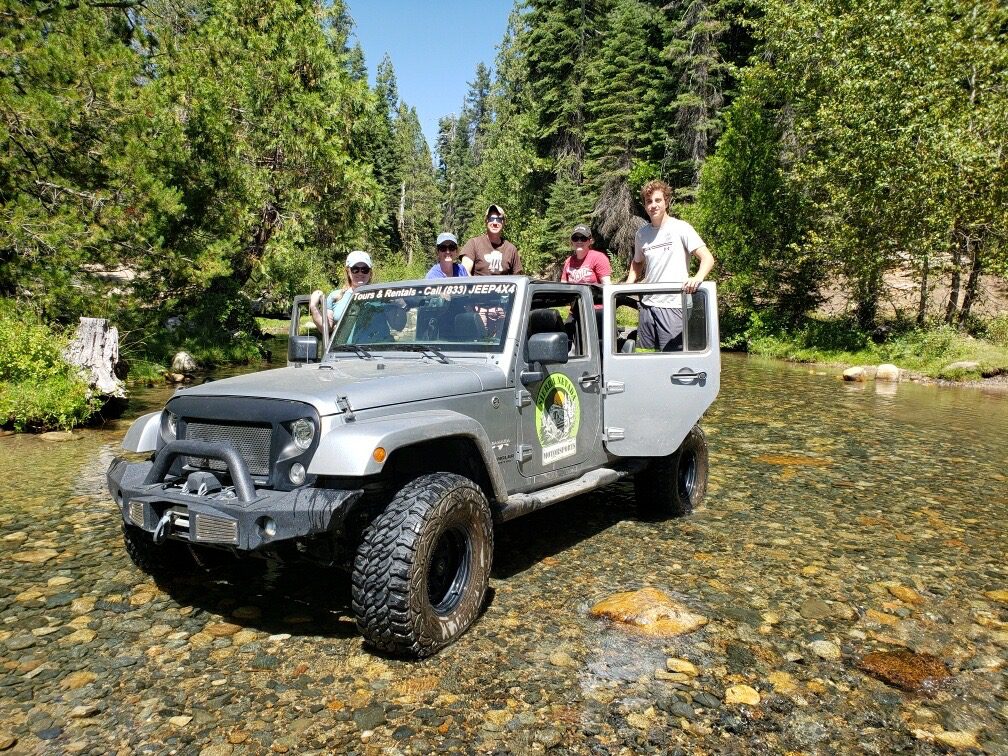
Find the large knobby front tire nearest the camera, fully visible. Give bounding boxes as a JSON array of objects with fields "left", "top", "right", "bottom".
[{"left": 352, "top": 473, "right": 494, "bottom": 658}]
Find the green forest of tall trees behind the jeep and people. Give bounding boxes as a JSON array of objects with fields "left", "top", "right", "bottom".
[{"left": 0, "top": 0, "right": 1008, "bottom": 426}]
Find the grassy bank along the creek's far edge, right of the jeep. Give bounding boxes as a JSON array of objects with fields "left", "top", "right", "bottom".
[{"left": 742, "top": 317, "right": 1008, "bottom": 381}]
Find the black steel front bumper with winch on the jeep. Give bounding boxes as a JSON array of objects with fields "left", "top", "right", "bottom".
[{"left": 106, "top": 449, "right": 364, "bottom": 551}]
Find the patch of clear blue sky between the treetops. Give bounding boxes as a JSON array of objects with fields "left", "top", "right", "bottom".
[{"left": 347, "top": 0, "right": 514, "bottom": 155}]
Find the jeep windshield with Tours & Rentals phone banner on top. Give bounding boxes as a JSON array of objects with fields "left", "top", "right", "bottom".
[{"left": 330, "top": 278, "right": 518, "bottom": 352}]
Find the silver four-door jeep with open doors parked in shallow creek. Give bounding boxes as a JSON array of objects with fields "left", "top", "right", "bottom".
[{"left": 108, "top": 276, "right": 721, "bottom": 656}]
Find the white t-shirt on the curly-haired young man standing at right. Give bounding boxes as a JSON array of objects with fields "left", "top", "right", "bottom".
[{"left": 633, "top": 216, "right": 705, "bottom": 307}]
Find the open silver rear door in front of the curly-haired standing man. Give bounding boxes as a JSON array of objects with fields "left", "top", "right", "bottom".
[{"left": 602, "top": 283, "right": 721, "bottom": 457}]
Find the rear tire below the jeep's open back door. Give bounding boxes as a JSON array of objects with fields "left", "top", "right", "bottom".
[{"left": 634, "top": 425, "right": 709, "bottom": 518}]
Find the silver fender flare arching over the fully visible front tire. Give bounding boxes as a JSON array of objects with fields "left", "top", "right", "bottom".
[{"left": 307, "top": 409, "right": 507, "bottom": 501}]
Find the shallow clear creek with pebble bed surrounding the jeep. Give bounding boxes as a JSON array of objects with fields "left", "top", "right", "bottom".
[{"left": 0, "top": 357, "right": 1008, "bottom": 755}]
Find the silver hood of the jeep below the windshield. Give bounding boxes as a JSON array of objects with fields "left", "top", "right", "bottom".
[{"left": 173, "top": 357, "right": 506, "bottom": 415}]
